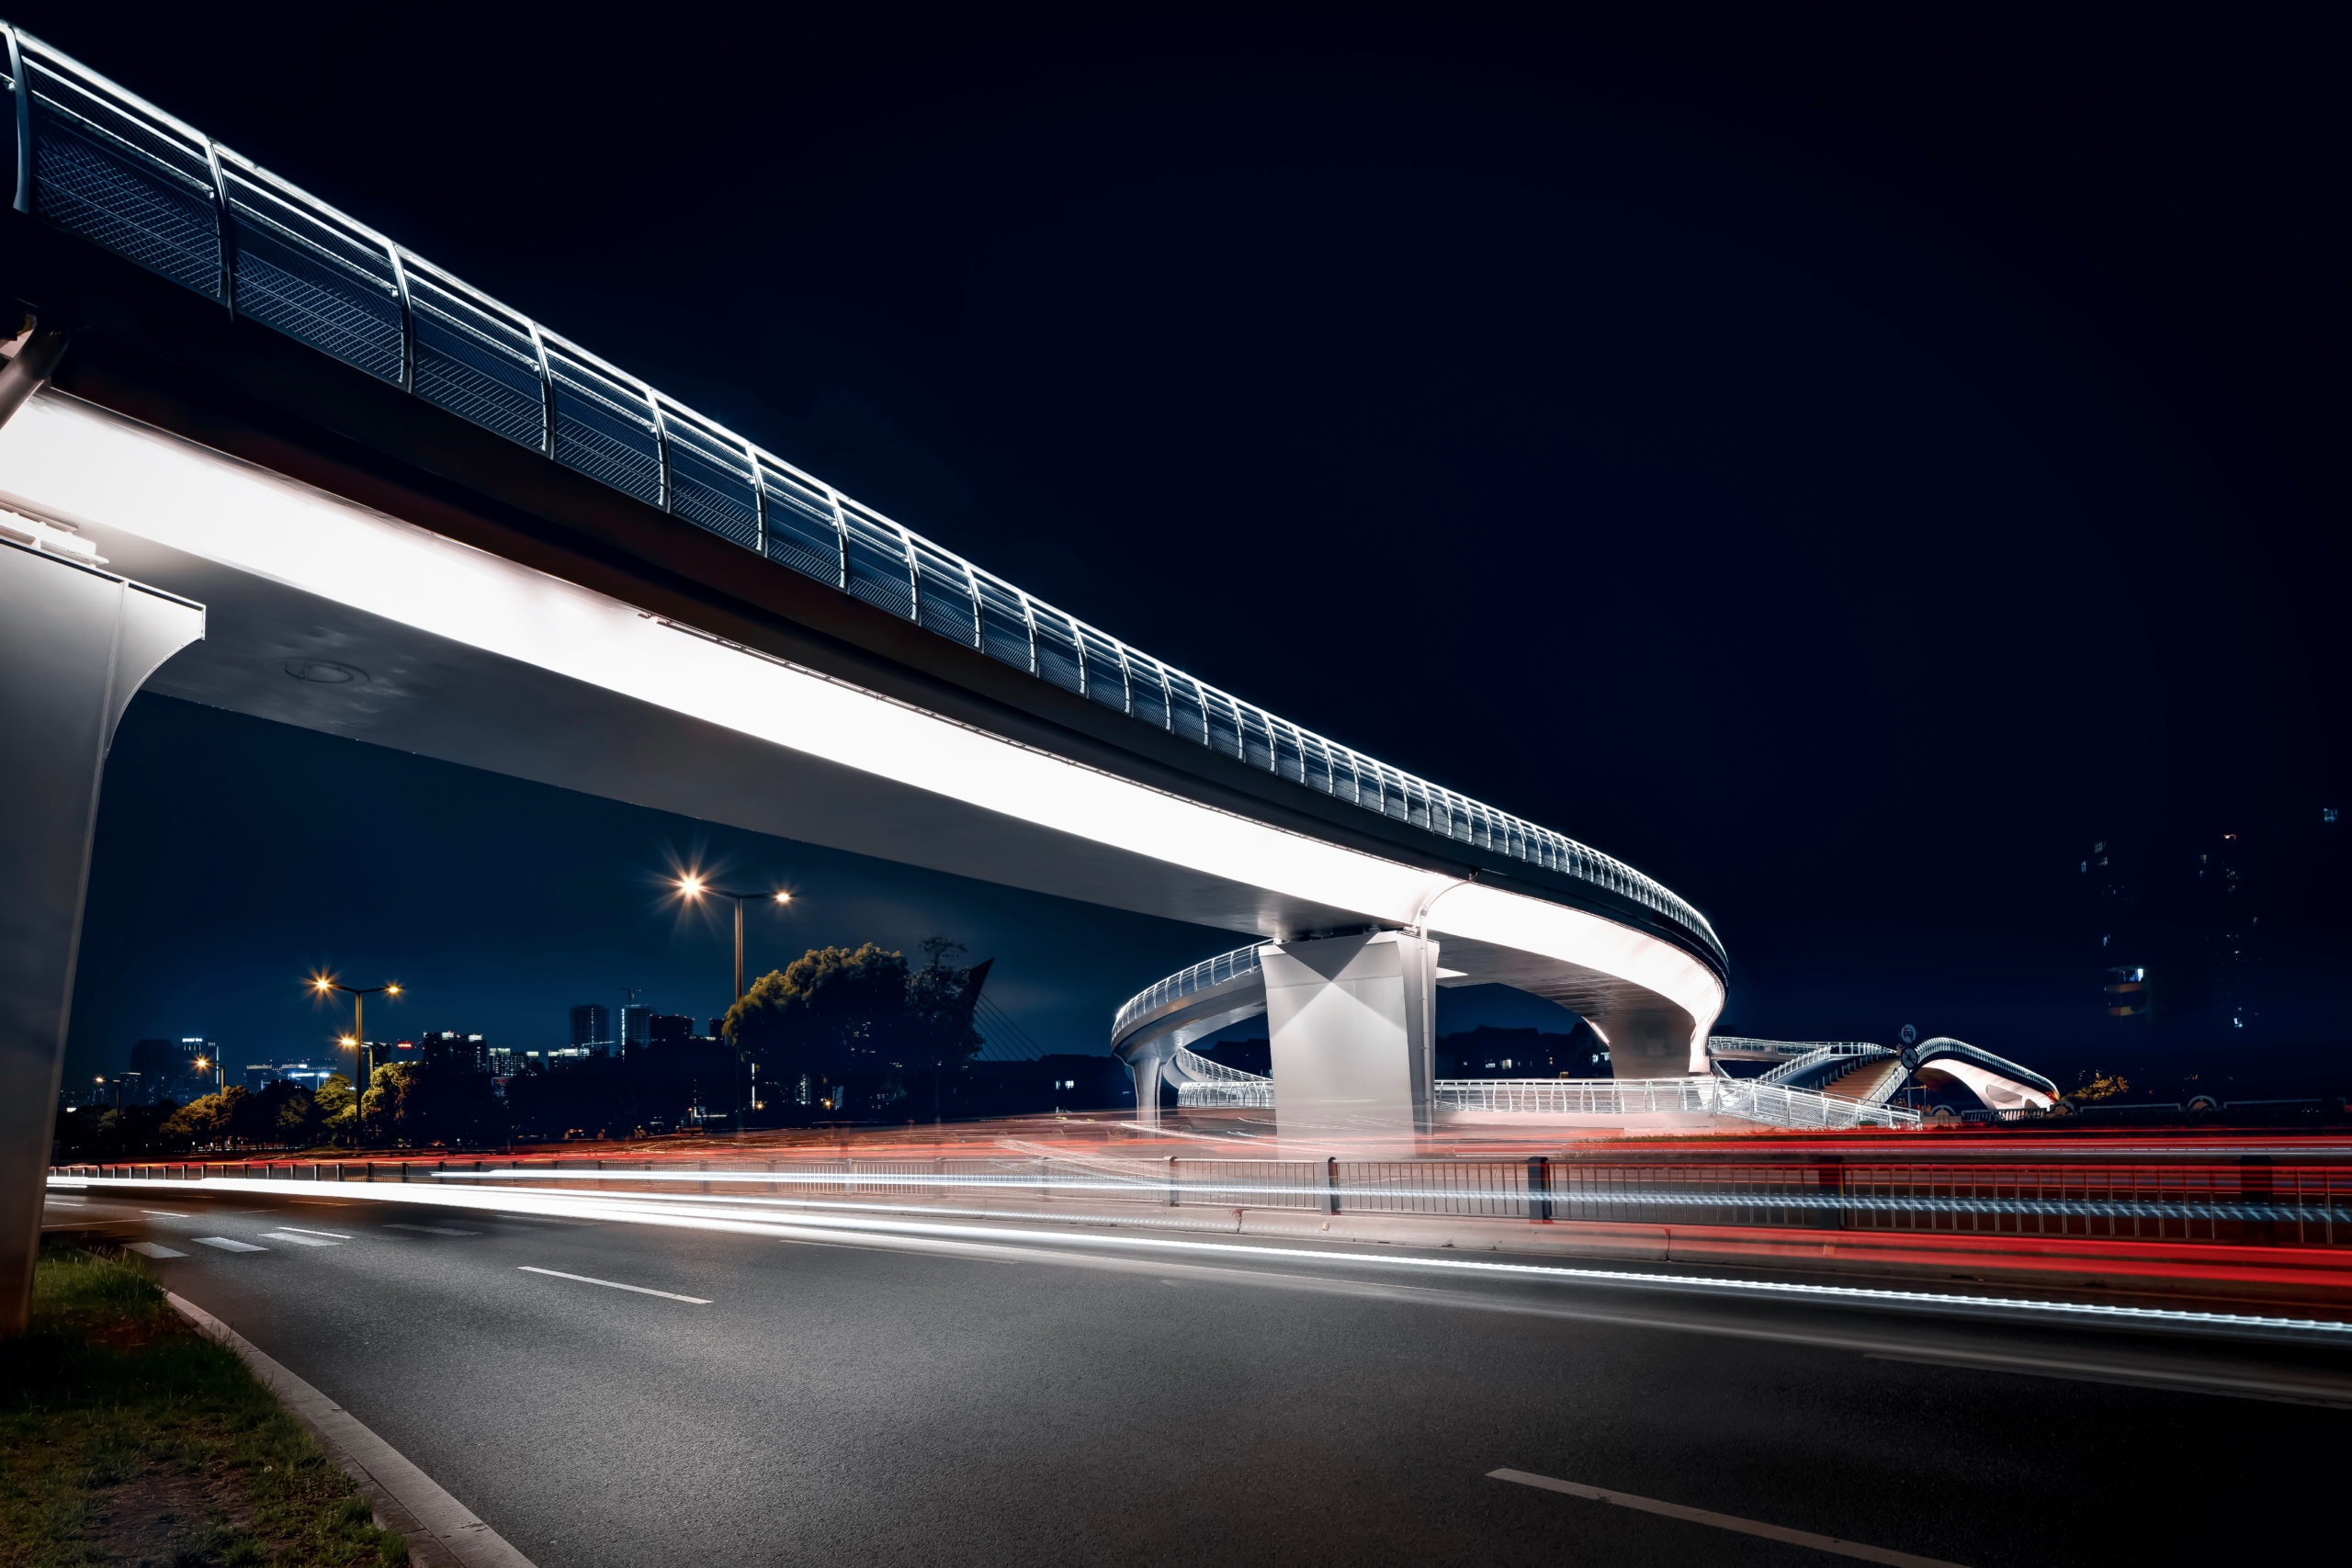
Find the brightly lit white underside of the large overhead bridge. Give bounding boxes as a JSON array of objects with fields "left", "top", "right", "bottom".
[{"left": 0, "top": 390, "right": 1722, "bottom": 1034}]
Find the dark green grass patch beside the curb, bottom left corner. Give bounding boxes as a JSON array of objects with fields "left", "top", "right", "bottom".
[{"left": 0, "top": 1248, "right": 409, "bottom": 1568}]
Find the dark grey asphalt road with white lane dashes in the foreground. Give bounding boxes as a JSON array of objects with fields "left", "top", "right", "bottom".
[{"left": 51, "top": 1192, "right": 2352, "bottom": 1568}]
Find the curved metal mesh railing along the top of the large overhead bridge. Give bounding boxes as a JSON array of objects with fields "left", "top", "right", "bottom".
[{"left": 0, "top": 24, "right": 1724, "bottom": 966}]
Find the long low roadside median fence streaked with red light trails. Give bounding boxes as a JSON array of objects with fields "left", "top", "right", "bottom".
[{"left": 51, "top": 1152, "right": 2352, "bottom": 1248}]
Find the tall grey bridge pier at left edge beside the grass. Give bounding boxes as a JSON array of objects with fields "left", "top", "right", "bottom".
[{"left": 0, "top": 543, "right": 205, "bottom": 1333}]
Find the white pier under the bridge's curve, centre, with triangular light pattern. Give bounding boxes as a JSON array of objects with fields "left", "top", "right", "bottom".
[{"left": 1259, "top": 931, "right": 1437, "bottom": 1155}]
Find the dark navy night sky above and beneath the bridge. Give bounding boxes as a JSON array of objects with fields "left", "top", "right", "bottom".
[{"left": 41, "top": 5, "right": 2352, "bottom": 1100}]
